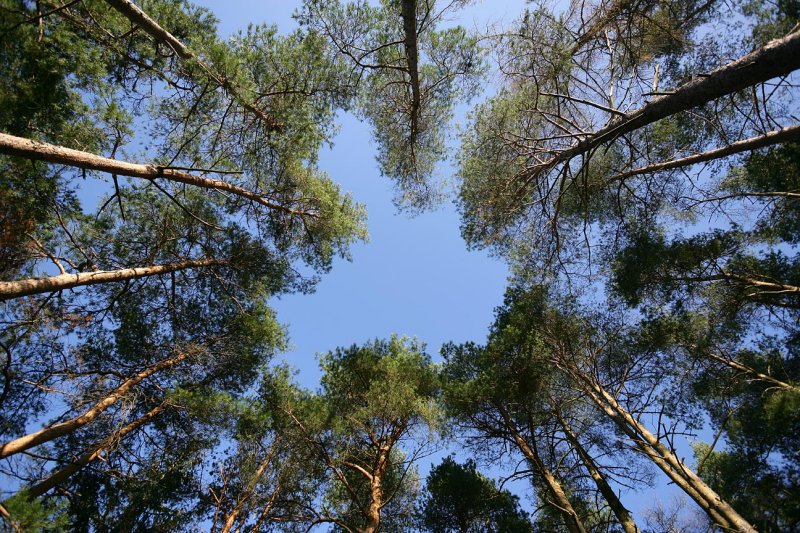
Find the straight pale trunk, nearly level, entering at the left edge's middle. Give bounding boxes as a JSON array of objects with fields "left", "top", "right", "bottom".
[{"left": 0, "top": 259, "right": 226, "bottom": 301}]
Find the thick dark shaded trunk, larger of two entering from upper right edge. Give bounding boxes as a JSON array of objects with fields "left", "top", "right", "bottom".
[{"left": 521, "top": 31, "right": 800, "bottom": 187}]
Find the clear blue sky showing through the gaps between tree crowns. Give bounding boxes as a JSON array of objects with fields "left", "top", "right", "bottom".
[{"left": 194, "top": 0, "right": 691, "bottom": 525}]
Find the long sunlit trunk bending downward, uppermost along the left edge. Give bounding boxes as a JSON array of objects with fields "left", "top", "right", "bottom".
[{"left": 0, "top": 133, "right": 314, "bottom": 216}]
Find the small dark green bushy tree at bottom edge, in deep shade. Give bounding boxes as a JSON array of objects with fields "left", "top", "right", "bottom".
[{"left": 417, "top": 456, "right": 533, "bottom": 533}]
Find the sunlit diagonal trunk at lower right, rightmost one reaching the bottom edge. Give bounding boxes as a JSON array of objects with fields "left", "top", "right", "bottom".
[{"left": 562, "top": 365, "right": 756, "bottom": 533}]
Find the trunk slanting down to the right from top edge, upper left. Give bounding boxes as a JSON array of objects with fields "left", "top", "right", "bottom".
[{"left": 106, "top": 0, "right": 284, "bottom": 131}]
